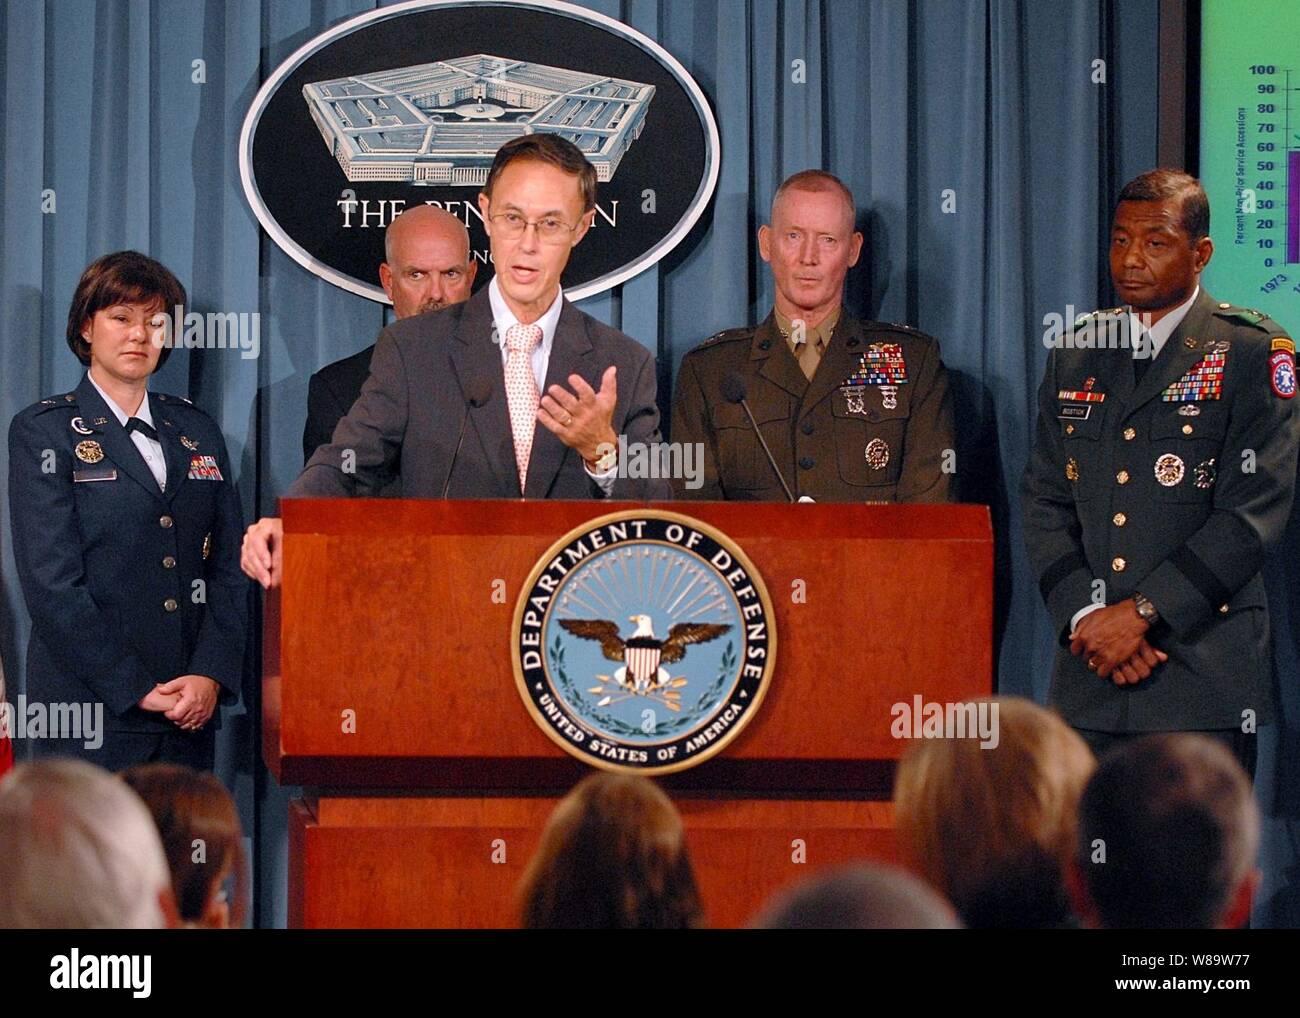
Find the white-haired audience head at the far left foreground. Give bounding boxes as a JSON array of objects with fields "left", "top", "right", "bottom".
[{"left": 0, "top": 759, "right": 177, "bottom": 930}]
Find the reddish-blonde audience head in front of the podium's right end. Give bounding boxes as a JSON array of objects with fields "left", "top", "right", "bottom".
[{"left": 894, "top": 697, "right": 1095, "bottom": 928}]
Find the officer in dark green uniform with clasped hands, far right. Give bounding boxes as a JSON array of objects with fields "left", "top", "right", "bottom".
[{"left": 1022, "top": 170, "right": 1300, "bottom": 775}]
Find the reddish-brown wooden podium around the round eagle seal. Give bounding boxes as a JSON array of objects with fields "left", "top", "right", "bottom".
[{"left": 263, "top": 499, "right": 993, "bottom": 927}]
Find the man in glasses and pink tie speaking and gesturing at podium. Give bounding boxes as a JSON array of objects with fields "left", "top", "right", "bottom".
[{"left": 242, "top": 134, "right": 670, "bottom": 586}]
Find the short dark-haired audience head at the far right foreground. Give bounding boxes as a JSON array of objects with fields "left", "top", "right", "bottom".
[{"left": 1070, "top": 733, "right": 1260, "bottom": 930}]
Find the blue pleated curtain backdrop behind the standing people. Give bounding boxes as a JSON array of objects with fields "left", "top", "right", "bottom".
[{"left": 0, "top": 0, "right": 1300, "bottom": 926}]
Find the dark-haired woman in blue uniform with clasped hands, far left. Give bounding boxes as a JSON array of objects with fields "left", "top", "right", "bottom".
[{"left": 9, "top": 251, "right": 247, "bottom": 771}]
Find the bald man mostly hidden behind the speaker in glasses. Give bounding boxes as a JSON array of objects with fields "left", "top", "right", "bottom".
[{"left": 303, "top": 205, "right": 478, "bottom": 495}]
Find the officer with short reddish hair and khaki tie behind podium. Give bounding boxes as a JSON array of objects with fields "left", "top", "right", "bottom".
[{"left": 672, "top": 170, "right": 956, "bottom": 502}]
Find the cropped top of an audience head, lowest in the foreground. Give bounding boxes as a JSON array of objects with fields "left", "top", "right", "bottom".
[{"left": 753, "top": 865, "right": 962, "bottom": 930}]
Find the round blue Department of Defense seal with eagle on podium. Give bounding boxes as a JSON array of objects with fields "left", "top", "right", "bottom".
[{"left": 511, "top": 510, "right": 776, "bottom": 775}]
